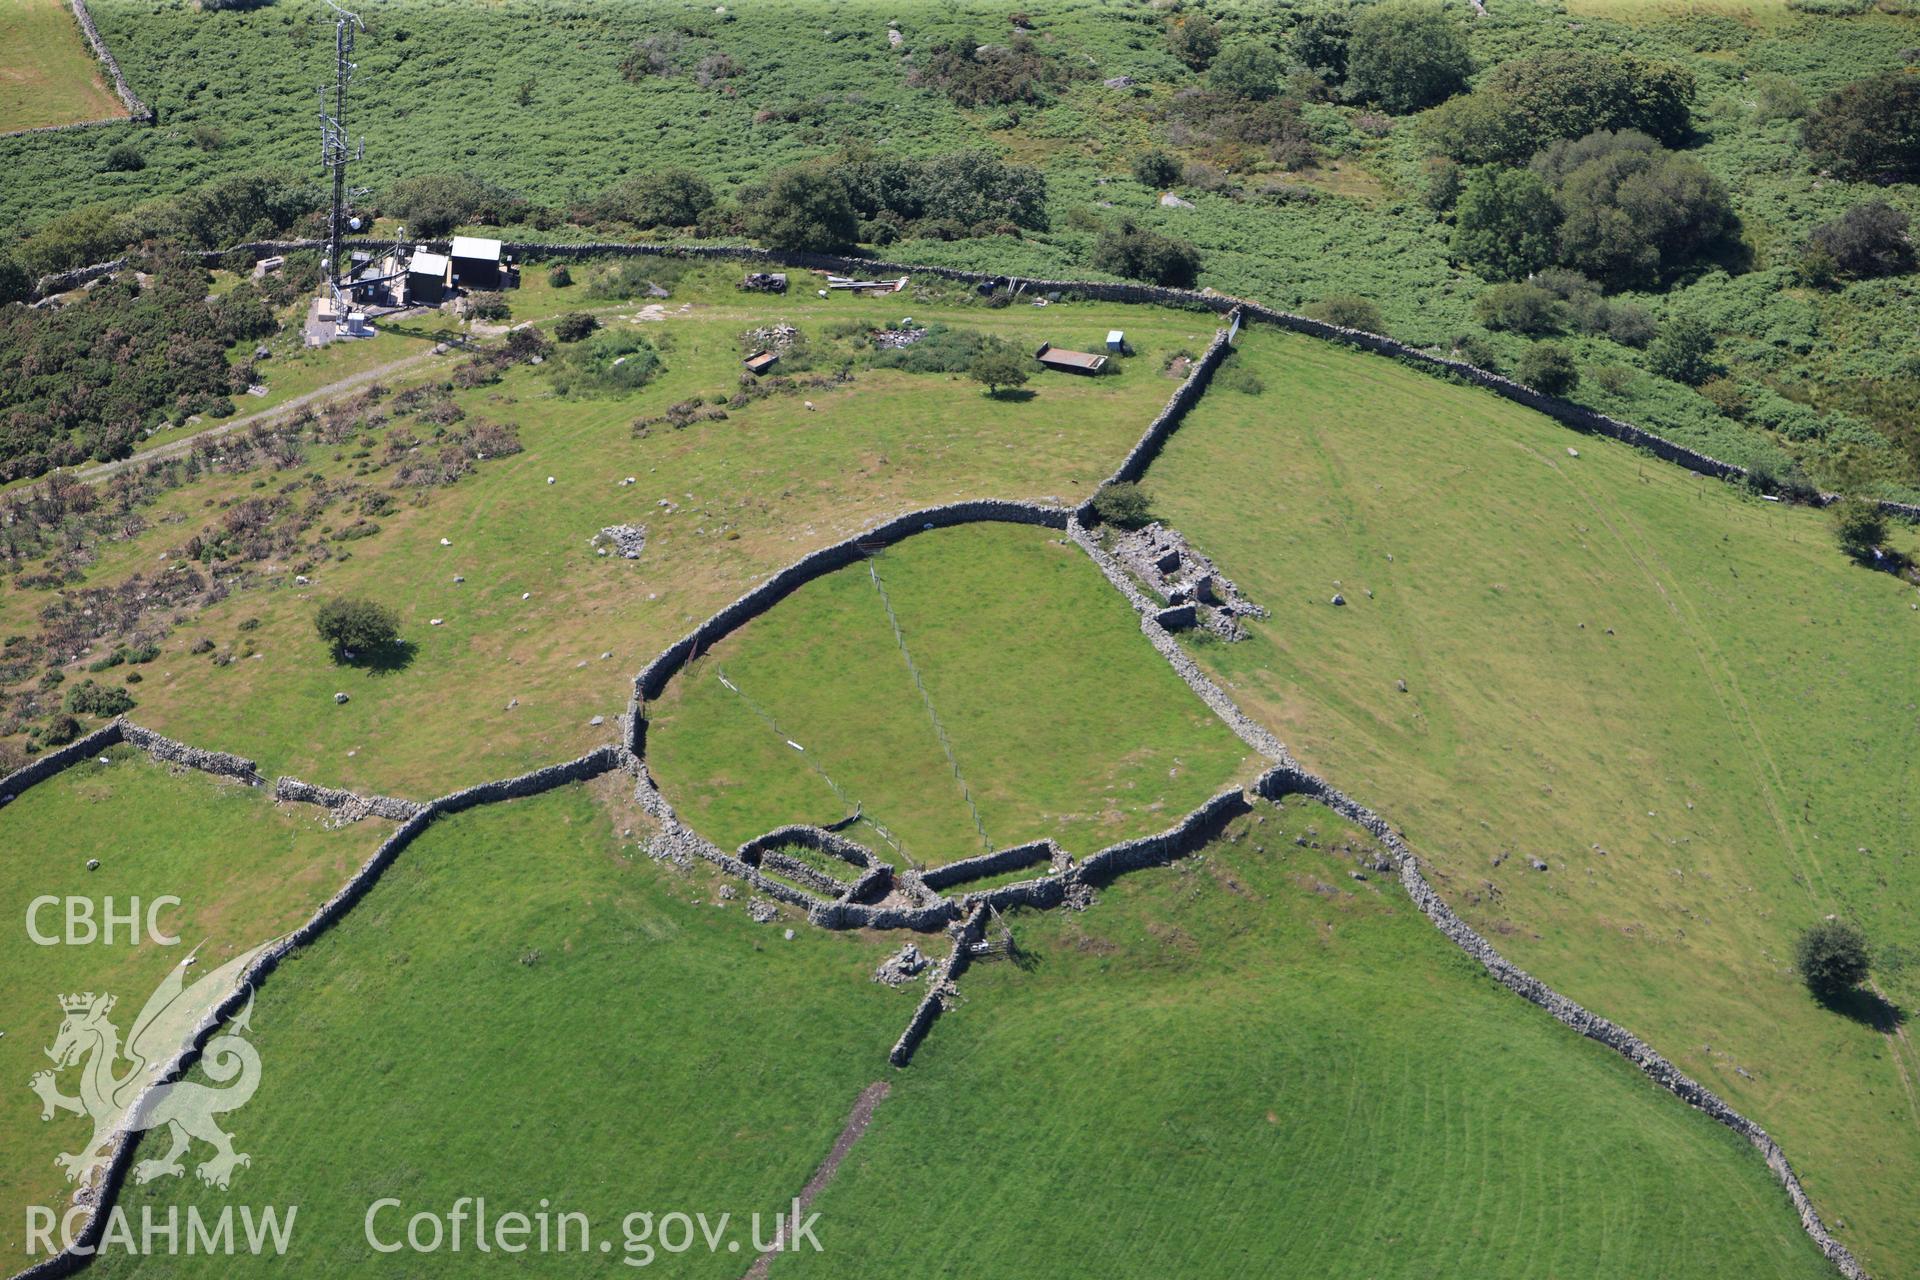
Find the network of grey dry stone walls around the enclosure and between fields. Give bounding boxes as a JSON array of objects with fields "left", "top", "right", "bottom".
[{"left": 11, "top": 246, "right": 1873, "bottom": 1280}]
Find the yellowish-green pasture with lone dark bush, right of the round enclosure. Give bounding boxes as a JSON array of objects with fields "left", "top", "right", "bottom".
[{"left": 1148, "top": 330, "right": 1920, "bottom": 1276}]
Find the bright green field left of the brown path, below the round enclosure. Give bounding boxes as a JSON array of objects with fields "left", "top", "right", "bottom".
[{"left": 92, "top": 787, "right": 912, "bottom": 1276}]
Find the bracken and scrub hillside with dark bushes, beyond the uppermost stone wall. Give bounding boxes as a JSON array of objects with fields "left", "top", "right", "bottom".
[{"left": 0, "top": 0, "right": 1920, "bottom": 497}]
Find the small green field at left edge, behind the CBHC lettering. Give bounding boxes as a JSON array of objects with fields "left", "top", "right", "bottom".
[{"left": 0, "top": 747, "right": 390, "bottom": 1270}]
